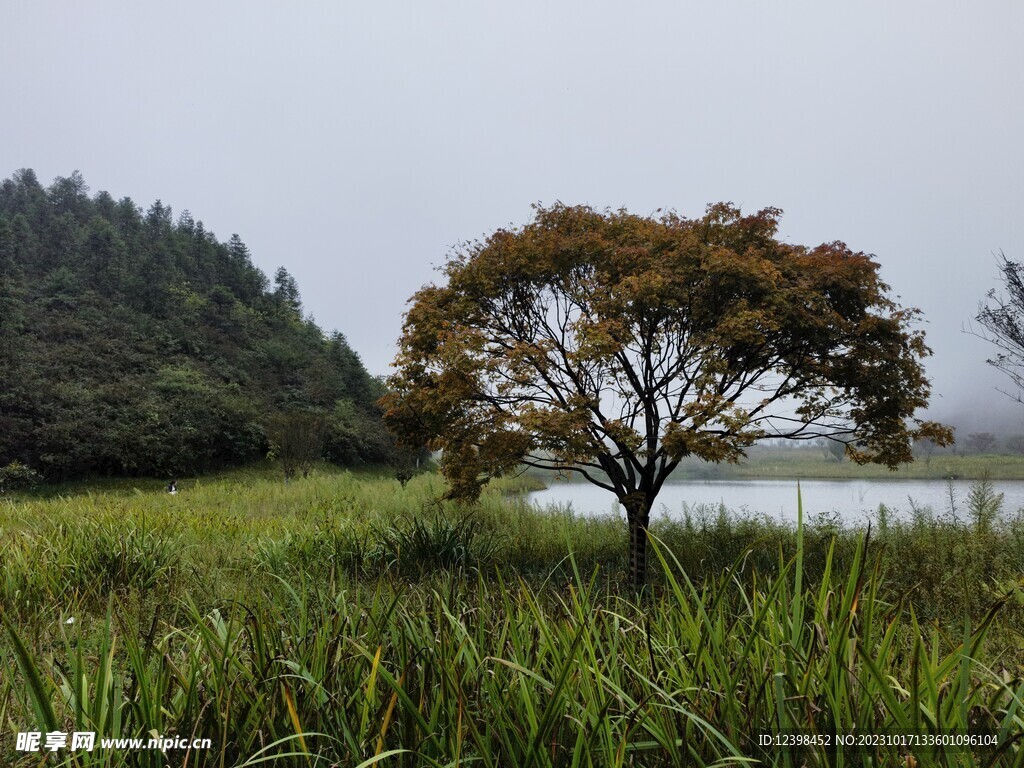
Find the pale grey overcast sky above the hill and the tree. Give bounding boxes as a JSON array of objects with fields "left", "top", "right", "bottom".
[{"left": 0, "top": 0, "right": 1024, "bottom": 428}]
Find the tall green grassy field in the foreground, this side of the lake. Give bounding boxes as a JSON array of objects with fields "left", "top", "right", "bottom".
[{"left": 0, "top": 468, "right": 1024, "bottom": 768}]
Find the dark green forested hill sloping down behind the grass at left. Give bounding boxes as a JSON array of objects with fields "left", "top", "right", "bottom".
[{"left": 0, "top": 170, "right": 390, "bottom": 479}]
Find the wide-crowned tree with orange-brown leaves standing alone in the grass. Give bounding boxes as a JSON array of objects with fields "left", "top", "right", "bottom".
[{"left": 383, "top": 204, "right": 952, "bottom": 591}]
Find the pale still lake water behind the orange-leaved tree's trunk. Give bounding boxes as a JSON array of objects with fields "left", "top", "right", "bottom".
[{"left": 527, "top": 479, "right": 1024, "bottom": 524}]
